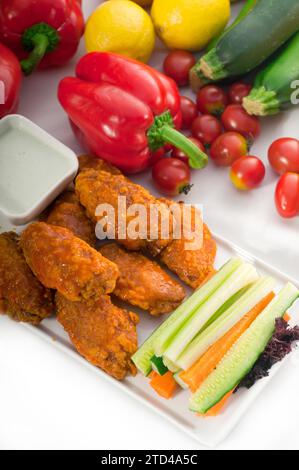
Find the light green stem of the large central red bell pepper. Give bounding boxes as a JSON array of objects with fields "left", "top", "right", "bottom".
[{"left": 147, "top": 111, "right": 208, "bottom": 169}]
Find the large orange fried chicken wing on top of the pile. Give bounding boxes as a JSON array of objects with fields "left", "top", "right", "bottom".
[{"left": 75, "top": 169, "right": 175, "bottom": 256}]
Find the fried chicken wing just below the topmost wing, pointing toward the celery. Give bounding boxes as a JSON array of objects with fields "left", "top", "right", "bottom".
[{"left": 100, "top": 243, "right": 185, "bottom": 315}]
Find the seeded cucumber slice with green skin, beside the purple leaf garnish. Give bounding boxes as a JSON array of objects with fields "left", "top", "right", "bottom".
[{"left": 189, "top": 283, "right": 299, "bottom": 414}]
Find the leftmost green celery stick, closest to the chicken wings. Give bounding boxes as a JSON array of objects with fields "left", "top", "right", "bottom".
[{"left": 132, "top": 258, "right": 243, "bottom": 375}]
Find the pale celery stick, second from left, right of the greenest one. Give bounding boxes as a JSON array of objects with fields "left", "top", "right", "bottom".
[{"left": 163, "top": 263, "right": 258, "bottom": 364}]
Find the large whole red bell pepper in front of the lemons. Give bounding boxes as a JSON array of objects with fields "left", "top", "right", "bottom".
[{"left": 58, "top": 53, "right": 208, "bottom": 173}]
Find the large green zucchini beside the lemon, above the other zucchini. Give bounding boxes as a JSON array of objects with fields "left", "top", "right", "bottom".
[{"left": 191, "top": 0, "right": 299, "bottom": 88}]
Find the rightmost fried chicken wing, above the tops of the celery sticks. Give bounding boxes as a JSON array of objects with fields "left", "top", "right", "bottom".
[{"left": 159, "top": 199, "right": 217, "bottom": 289}]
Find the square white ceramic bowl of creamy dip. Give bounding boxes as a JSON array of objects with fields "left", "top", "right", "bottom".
[{"left": 0, "top": 114, "right": 78, "bottom": 225}]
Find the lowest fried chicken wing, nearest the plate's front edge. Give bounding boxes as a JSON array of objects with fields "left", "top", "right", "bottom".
[{"left": 56, "top": 294, "right": 138, "bottom": 380}]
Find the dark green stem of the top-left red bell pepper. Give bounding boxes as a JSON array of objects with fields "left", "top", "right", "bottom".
[{"left": 21, "top": 23, "right": 59, "bottom": 75}]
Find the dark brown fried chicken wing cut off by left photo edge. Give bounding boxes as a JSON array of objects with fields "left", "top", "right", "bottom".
[{"left": 0, "top": 232, "right": 54, "bottom": 325}]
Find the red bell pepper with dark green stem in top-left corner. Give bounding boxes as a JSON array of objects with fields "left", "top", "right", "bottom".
[{"left": 0, "top": 0, "right": 84, "bottom": 75}]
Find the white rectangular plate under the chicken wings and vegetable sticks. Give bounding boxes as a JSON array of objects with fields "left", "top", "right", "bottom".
[{"left": 18, "top": 236, "right": 299, "bottom": 447}]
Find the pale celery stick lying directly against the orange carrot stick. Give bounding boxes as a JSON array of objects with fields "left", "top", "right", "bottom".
[{"left": 176, "top": 277, "right": 275, "bottom": 370}]
